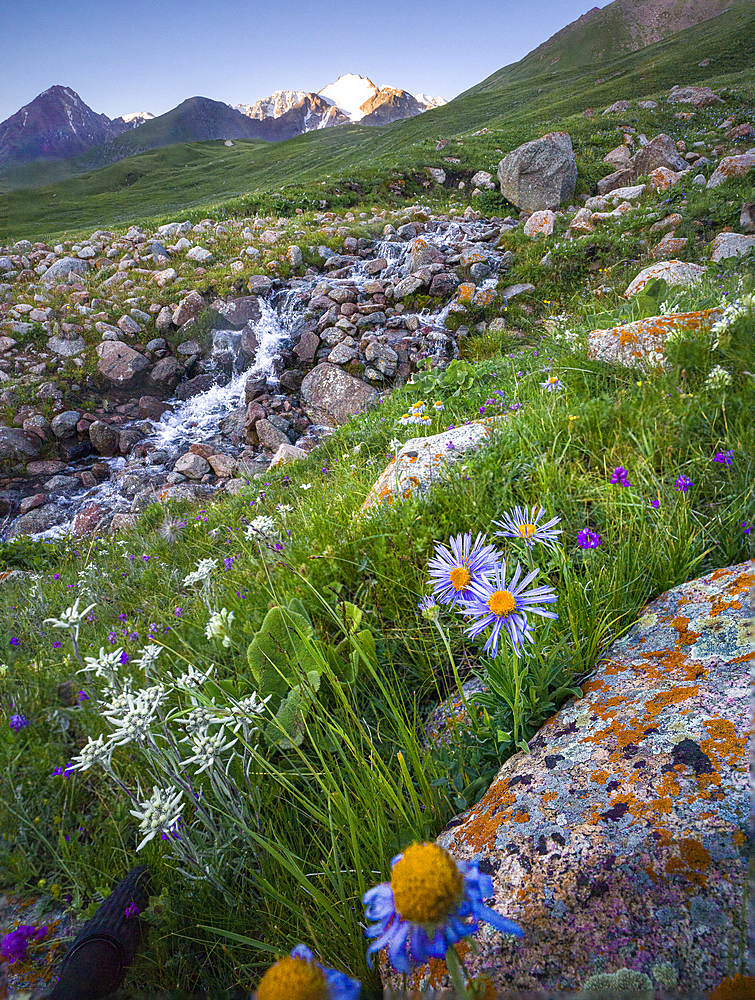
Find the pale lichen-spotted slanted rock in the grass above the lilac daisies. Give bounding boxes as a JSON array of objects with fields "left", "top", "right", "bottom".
[{"left": 361, "top": 417, "right": 501, "bottom": 513}]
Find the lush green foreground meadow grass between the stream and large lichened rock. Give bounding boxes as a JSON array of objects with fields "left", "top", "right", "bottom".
[{"left": 0, "top": 248, "right": 755, "bottom": 995}]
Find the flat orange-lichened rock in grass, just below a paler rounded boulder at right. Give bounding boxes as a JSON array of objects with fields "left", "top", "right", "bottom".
[{"left": 587, "top": 309, "right": 721, "bottom": 371}]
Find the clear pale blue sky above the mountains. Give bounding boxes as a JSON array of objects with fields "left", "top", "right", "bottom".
[{"left": 0, "top": 0, "right": 606, "bottom": 121}]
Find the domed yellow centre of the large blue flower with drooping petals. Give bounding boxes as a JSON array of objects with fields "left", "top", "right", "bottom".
[{"left": 391, "top": 844, "right": 464, "bottom": 924}]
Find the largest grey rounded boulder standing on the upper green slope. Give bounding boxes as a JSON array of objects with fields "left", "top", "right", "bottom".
[{"left": 498, "top": 132, "right": 577, "bottom": 213}]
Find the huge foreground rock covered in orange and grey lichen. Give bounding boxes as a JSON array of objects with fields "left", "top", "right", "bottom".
[{"left": 402, "top": 560, "right": 755, "bottom": 995}]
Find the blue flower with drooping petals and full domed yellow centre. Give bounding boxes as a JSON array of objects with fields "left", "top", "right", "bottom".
[{"left": 362, "top": 843, "right": 523, "bottom": 973}]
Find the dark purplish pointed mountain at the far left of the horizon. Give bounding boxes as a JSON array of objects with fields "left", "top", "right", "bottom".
[{"left": 0, "top": 86, "right": 132, "bottom": 163}]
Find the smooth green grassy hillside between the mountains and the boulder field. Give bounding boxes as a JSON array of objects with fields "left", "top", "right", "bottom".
[{"left": 0, "top": 0, "right": 755, "bottom": 241}]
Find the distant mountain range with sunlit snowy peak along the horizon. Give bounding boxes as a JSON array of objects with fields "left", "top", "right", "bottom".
[{"left": 0, "top": 74, "right": 445, "bottom": 167}]
